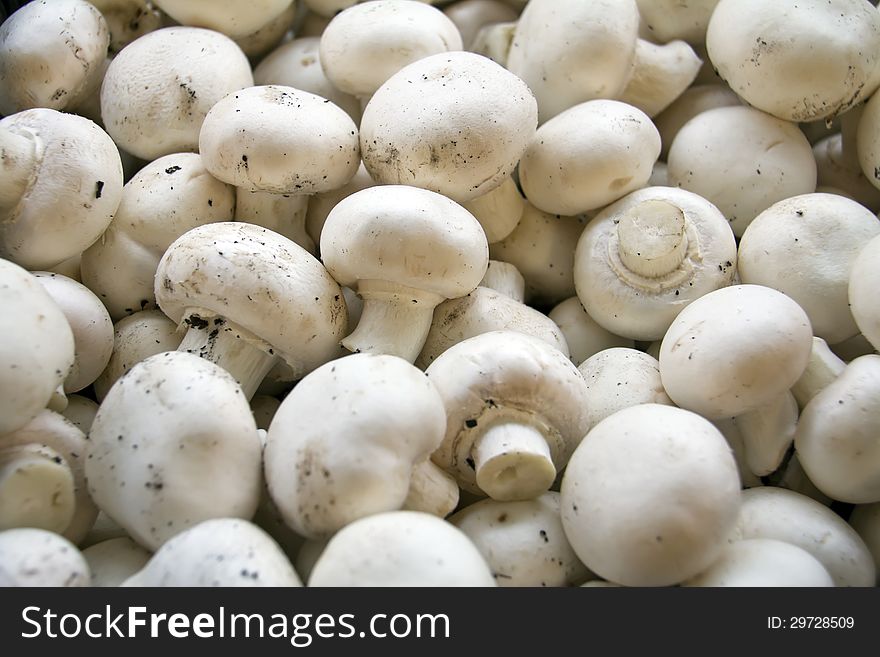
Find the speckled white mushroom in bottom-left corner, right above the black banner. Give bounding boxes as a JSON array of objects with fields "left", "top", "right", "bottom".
[{"left": 0, "top": 528, "right": 91, "bottom": 588}]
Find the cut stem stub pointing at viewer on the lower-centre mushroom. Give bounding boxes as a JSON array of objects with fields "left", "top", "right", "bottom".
[{"left": 471, "top": 422, "right": 556, "bottom": 502}]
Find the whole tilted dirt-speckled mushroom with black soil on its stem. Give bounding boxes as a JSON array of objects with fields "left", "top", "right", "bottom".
[{"left": 156, "top": 222, "right": 347, "bottom": 399}]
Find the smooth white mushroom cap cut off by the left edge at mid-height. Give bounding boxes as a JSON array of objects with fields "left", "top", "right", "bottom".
[{"left": 0, "top": 259, "right": 75, "bottom": 436}]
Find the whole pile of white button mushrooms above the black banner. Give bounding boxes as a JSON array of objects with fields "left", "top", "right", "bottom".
[{"left": 0, "top": 0, "right": 880, "bottom": 588}]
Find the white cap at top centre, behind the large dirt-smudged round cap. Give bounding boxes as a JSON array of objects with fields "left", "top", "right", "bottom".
[{"left": 321, "top": 0, "right": 463, "bottom": 97}]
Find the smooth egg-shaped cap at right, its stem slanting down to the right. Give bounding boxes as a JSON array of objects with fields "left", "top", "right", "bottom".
[{"left": 660, "top": 285, "right": 813, "bottom": 419}]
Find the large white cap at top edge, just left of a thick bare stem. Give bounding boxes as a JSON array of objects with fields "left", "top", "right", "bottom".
[{"left": 507, "top": 0, "right": 639, "bottom": 123}]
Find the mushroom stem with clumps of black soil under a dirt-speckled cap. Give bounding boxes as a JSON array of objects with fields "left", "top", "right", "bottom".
[{"left": 177, "top": 310, "right": 278, "bottom": 401}]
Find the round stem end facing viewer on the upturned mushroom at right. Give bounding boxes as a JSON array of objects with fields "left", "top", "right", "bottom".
[{"left": 617, "top": 199, "right": 688, "bottom": 278}]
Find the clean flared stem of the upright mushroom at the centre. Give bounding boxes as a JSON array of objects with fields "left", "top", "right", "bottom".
[{"left": 342, "top": 280, "right": 443, "bottom": 363}]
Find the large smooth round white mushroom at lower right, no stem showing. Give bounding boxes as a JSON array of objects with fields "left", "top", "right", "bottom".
[{"left": 560, "top": 404, "right": 740, "bottom": 586}]
